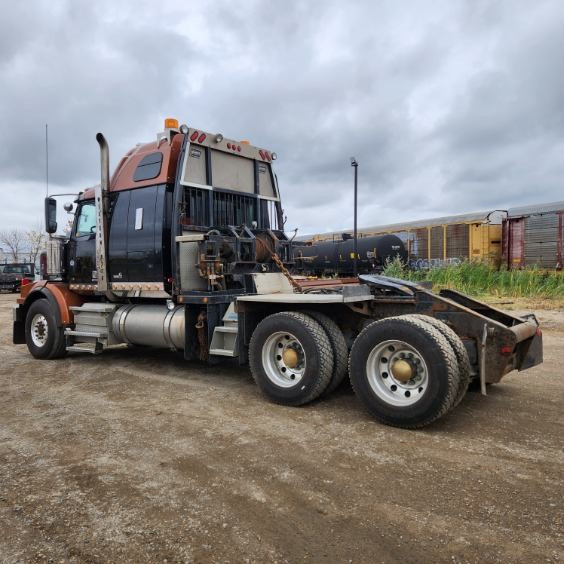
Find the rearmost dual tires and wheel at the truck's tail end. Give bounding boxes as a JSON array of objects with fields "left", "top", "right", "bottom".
[{"left": 349, "top": 315, "right": 459, "bottom": 429}]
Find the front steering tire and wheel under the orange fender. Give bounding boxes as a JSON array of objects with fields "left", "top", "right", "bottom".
[{"left": 25, "top": 299, "right": 66, "bottom": 359}]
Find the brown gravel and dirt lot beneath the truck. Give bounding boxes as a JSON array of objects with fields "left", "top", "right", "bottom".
[{"left": 0, "top": 295, "right": 564, "bottom": 562}]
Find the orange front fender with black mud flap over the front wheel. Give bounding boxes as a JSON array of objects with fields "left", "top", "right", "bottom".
[{"left": 13, "top": 280, "right": 86, "bottom": 344}]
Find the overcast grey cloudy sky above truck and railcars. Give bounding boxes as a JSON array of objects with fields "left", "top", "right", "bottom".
[{"left": 0, "top": 0, "right": 564, "bottom": 234}]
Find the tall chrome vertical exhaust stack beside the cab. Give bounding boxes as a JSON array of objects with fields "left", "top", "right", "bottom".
[{"left": 94, "top": 133, "right": 110, "bottom": 293}]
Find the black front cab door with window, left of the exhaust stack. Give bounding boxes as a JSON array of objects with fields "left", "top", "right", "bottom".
[{"left": 68, "top": 201, "right": 97, "bottom": 284}]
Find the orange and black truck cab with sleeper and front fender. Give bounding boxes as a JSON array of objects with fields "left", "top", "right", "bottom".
[{"left": 14, "top": 119, "right": 289, "bottom": 343}]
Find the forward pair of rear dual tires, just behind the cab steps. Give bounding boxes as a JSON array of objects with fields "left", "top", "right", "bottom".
[{"left": 249, "top": 311, "right": 333, "bottom": 406}]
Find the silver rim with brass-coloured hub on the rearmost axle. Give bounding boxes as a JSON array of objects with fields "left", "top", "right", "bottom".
[{"left": 366, "top": 341, "right": 429, "bottom": 407}]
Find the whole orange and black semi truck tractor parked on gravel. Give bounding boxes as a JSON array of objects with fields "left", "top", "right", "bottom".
[{"left": 13, "top": 119, "right": 542, "bottom": 428}]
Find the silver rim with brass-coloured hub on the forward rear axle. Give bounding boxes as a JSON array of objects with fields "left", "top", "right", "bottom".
[{"left": 262, "top": 332, "right": 306, "bottom": 388}]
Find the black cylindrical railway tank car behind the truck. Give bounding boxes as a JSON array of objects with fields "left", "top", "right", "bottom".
[{"left": 294, "top": 235, "right": 408, "bottom": 275}]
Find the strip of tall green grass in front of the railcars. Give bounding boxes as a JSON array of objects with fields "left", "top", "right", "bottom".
[{"left": 384, "top": 259, "right": 564, "bottom": 300}]
